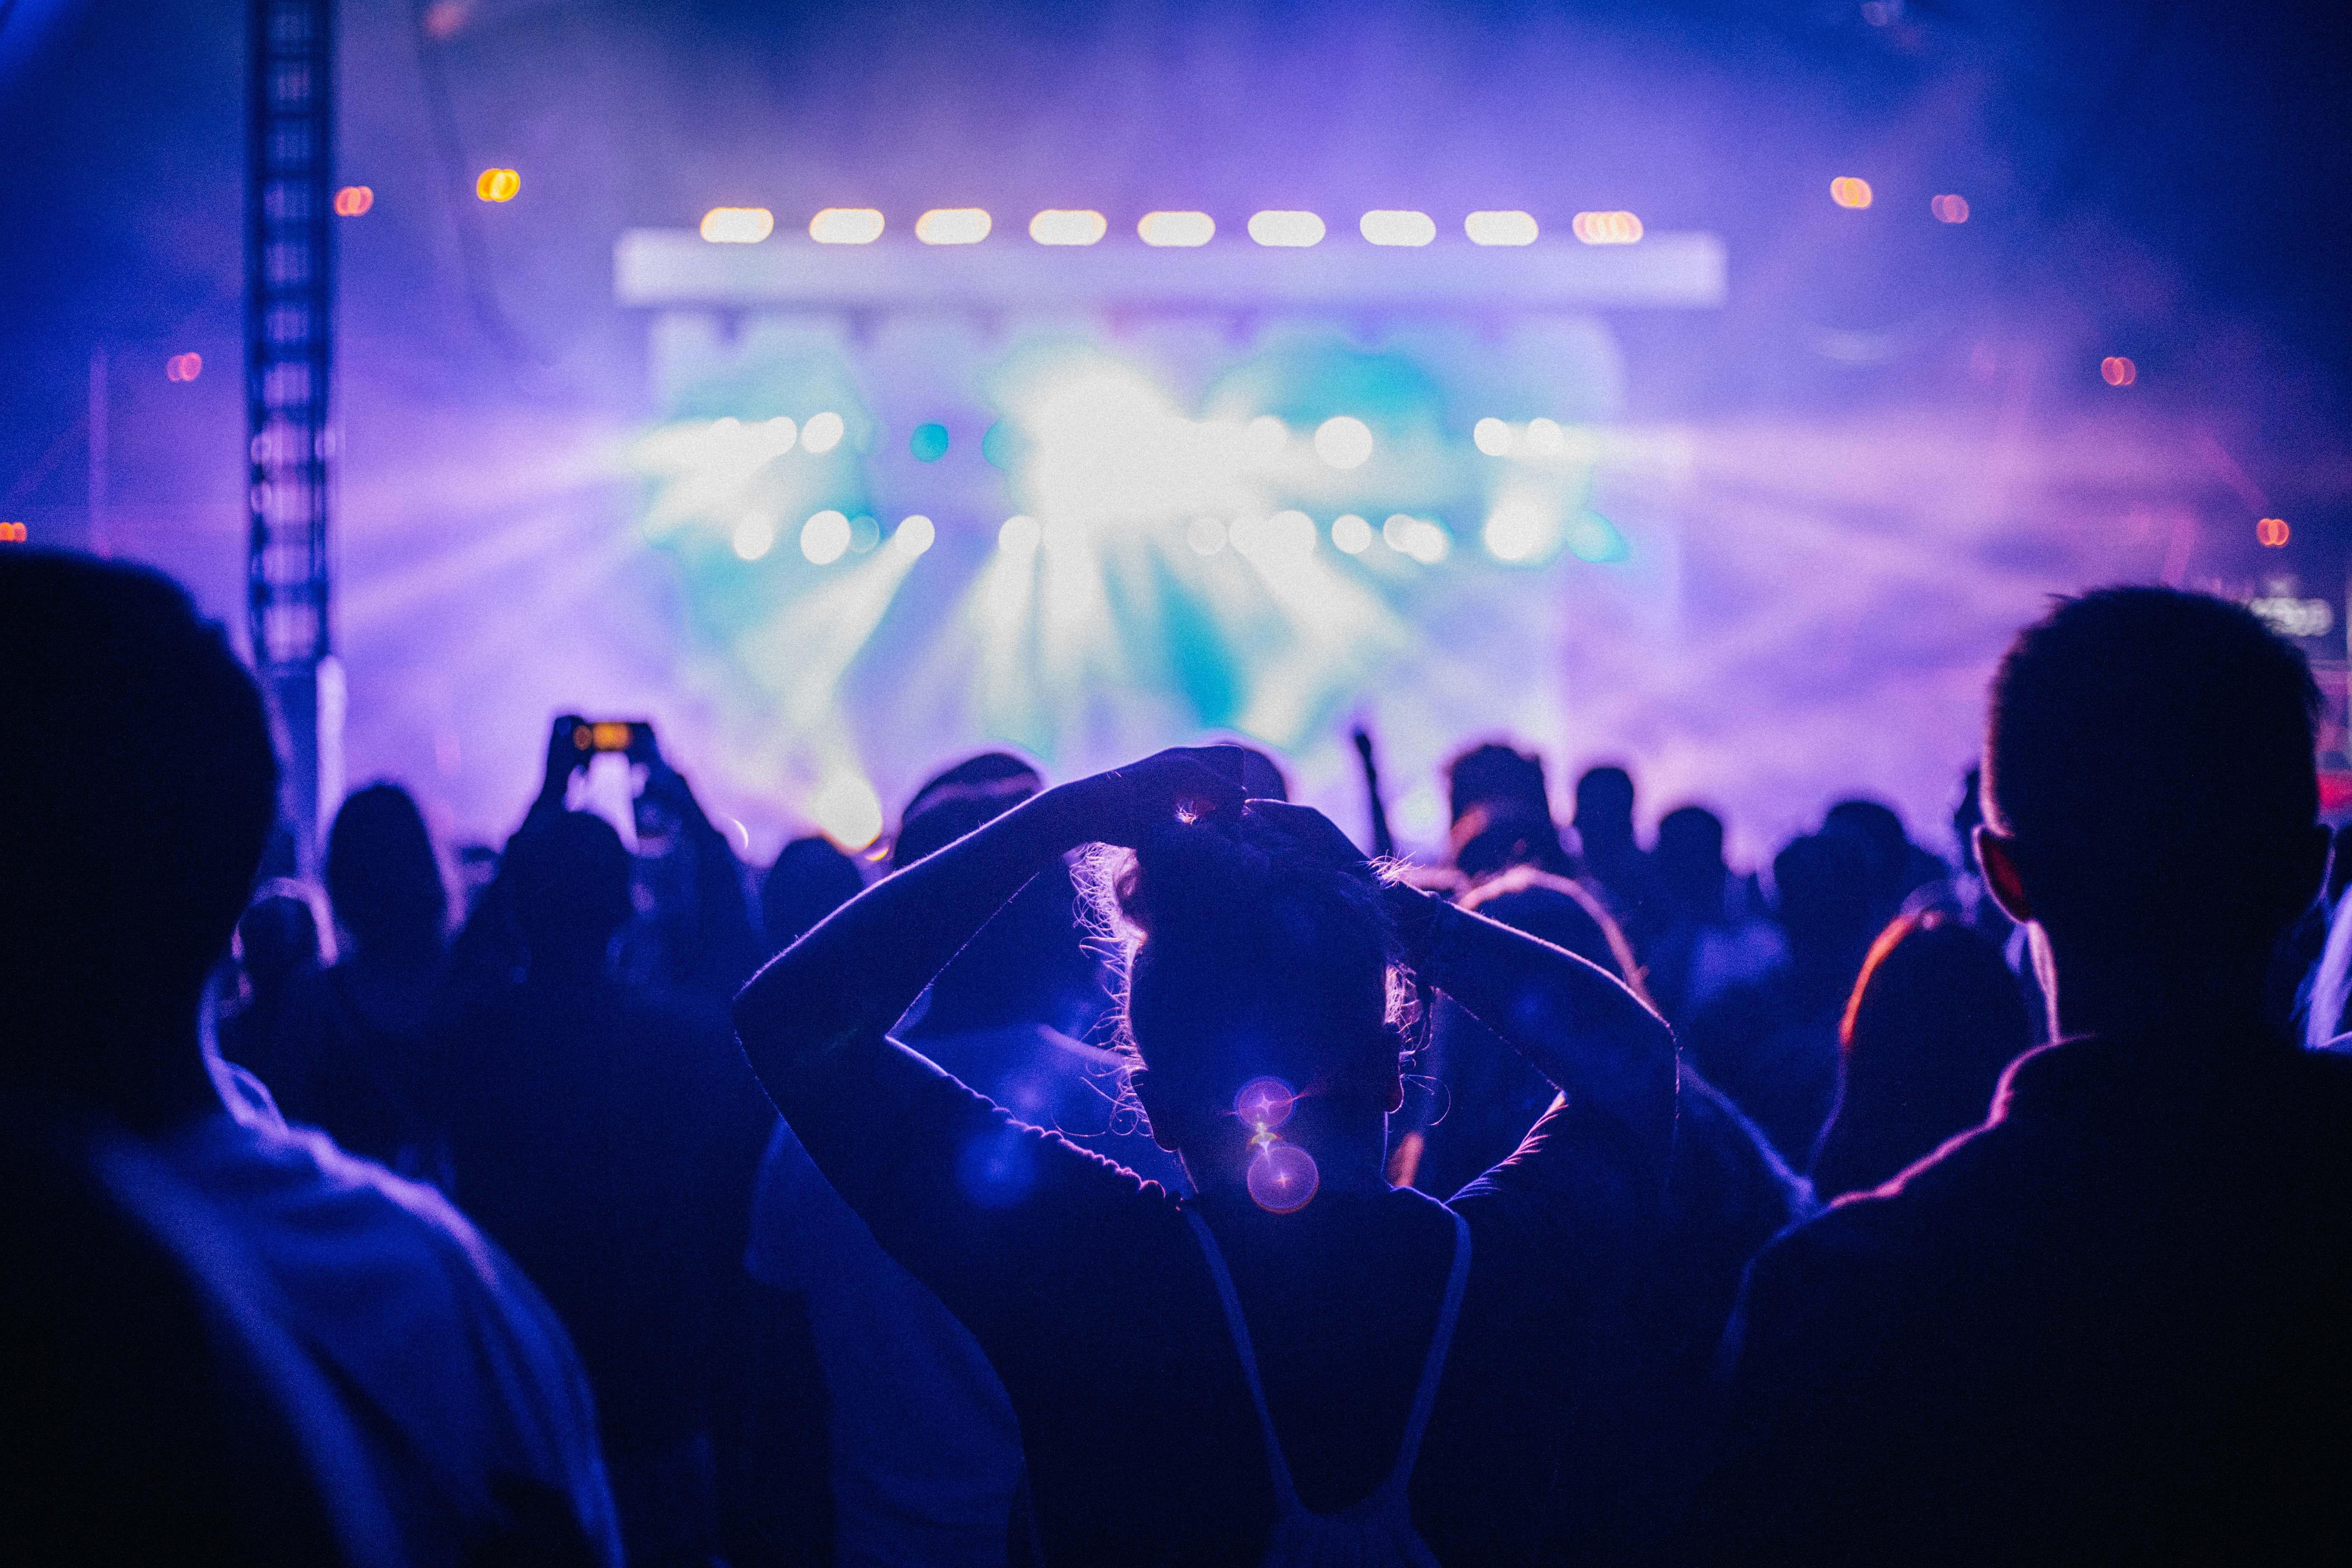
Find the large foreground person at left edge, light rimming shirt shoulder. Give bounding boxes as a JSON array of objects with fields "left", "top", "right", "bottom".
[{"left": 0, "top": 550, "right": 619, "bottom": 1563}]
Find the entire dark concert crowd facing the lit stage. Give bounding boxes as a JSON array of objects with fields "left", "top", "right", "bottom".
[{"left": 0, "top": 553, "right": 2352, "bottom": 1568}]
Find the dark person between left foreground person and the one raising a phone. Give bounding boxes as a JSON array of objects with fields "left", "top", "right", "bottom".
[{"left": 256, "top": 783, "right": 449, "bottom": 1187}]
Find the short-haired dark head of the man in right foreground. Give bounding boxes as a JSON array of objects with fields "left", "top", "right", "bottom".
[{"left": 1980, "top": 588, "right": 2326, "bottom": 966}]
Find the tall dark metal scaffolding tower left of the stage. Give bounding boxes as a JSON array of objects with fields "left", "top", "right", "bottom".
[{"left": 245, "top": 0, "right": 341, "bottom": 865}]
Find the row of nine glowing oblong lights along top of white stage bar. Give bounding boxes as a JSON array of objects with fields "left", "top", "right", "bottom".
[{"left": 687, "top": 198, "right": 1642, "bottom": 249}]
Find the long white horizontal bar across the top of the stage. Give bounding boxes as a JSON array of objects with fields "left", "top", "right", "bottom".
[{"left": 614, "top": 228, "right": 1726, "bottom": 315}]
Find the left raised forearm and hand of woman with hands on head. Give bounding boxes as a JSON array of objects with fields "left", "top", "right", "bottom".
[{"left": 736, "top": 750, "right": 1242, "bottom": 1086}]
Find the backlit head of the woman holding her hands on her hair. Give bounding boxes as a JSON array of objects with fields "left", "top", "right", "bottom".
[{"left": 1089, "top": 811, "right": 1407, "bottom": 1147}]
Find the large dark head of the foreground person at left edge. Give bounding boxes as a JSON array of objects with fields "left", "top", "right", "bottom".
[{"left": 0, "top": 550, "right": 277, "bottom": 1096}]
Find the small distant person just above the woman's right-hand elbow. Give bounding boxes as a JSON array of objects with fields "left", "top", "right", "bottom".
[{"left": 1647, "top": 806, "right": 1788, "bottom": 1027}]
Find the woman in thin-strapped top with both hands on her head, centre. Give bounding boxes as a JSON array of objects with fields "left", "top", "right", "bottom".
[{"left": 736, "top": 748, "right": 1675, "bottom": 1565}]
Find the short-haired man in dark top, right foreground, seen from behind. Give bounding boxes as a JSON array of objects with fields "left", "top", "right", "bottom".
[{"left": 1710, "top": 588, "right": 2352, "bottom": 1563}]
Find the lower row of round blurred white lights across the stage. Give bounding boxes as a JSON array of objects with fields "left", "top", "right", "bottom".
[{"left": 731, "top": 503, "right": 1625, "bottom": 566}]
